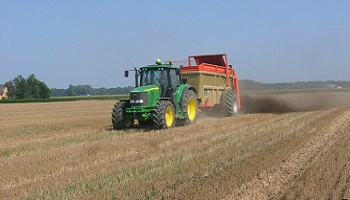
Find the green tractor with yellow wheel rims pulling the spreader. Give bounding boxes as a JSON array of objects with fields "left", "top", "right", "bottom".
[{"left": 112, "top": 59, "right": 198, "bottom": 130}]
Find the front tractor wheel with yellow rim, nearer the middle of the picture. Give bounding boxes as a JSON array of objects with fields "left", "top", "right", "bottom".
[{"left": 153, "top": 101, "right": 175, "bottom": 129}]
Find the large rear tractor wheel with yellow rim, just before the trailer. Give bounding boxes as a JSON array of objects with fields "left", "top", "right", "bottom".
[{"left": 181, "top": 90, "right": 198, "bottom": 125}]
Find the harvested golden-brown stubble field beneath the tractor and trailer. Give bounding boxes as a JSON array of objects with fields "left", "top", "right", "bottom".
[{"left": 0, "top": 92, "right": 350, "bottom": 199}]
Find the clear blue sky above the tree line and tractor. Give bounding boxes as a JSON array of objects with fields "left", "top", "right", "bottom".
[{"left": 0, "top": 0, "right": 350, "bottom": 88}]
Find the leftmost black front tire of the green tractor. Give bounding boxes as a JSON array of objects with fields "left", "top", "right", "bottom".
[{"left": 112, "top": 101, "right": 134, "bottom": 130}]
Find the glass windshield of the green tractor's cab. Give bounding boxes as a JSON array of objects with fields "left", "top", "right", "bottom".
[{"left": 140, "top": 68, "right": 166, "bottom": 86}]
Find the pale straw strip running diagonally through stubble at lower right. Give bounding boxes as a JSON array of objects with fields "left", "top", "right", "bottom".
[{"left": 227, "top": 107, "right": 350, "bottom": 199}]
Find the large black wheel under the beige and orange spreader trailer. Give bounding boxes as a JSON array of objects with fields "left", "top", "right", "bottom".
[{"left": 220, "top": 89, "right": 239, "bottom": 117}]
